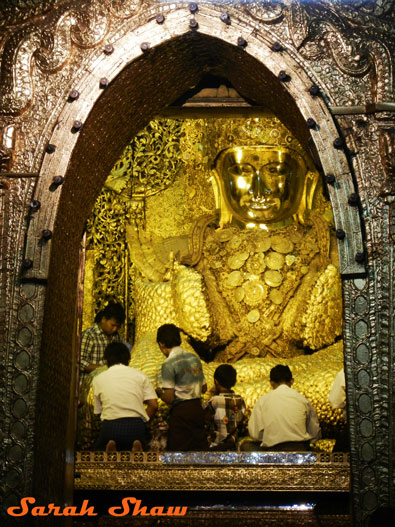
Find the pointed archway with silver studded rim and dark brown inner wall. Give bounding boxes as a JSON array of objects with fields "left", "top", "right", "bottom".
[{"left": 2, "top": 6, "right": 392, "bottom": 527}]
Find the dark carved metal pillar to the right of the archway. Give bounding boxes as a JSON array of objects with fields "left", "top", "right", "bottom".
[{"left": 340, "top": 114, "right": 395, "bottom": 526}]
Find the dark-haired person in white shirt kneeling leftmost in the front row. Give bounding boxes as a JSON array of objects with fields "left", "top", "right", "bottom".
[{"left": 93, "top": 342, "right": 158, "bottom": 451}]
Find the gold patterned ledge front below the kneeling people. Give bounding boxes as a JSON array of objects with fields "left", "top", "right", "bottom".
[{"left": 75, "top": 452, "right": 350, "bottom": 492}]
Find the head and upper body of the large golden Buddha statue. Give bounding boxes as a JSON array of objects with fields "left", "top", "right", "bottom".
[{"left": 128, "top": 145, "right": 342, "bottom": 362}]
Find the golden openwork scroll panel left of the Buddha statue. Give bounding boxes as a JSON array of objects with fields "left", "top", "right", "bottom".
[{"left": 83, "top": 119, "right": 181, "bottom": 330}]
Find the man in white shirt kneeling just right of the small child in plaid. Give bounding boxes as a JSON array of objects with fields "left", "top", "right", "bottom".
[{"left": 243, "top": 364, "right": 321, "bottom": 451}]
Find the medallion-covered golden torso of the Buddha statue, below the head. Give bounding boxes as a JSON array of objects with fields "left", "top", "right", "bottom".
[{"left": 181, "top": 218, "right": 342, "bottom": 362}]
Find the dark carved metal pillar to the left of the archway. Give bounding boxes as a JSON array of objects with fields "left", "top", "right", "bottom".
[{"left": 0, "top": 173, "right": 46, "bottom": 525}]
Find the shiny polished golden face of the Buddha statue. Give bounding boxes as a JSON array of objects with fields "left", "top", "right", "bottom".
[{"left": 216, "top": 146, "right": 304, "bottom": 224}]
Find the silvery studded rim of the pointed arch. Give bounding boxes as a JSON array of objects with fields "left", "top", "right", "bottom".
[{"left": 25, "top": 6, "right": 365, "bottom": 279}]
